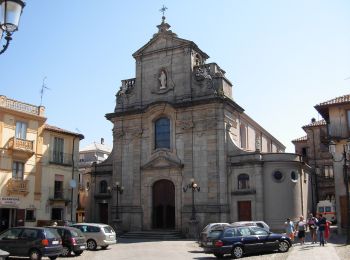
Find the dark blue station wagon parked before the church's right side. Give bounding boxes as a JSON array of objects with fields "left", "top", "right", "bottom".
[{"left": 203, "top": 226, "right": 292, "bottom": 258}]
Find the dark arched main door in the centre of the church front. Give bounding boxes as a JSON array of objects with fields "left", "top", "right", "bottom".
[{"left": 152, "top": 180, "right": 175, "bottom": 229}]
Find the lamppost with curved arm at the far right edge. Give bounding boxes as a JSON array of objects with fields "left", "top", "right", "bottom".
[{"left": 329, "top": 138, "right": 350, "bottom": 245}]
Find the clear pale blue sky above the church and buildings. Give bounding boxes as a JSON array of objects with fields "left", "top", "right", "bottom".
[{"left": 0, "top": 0, "right": 350, "bottom": 152}]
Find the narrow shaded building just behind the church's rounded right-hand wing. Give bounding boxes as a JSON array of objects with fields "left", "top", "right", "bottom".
[{"left": 292, "top": 118, "right": 335, "bottom": 213}]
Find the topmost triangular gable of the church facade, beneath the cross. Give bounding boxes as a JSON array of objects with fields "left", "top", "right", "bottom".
[{"left": 132, "top": 16, "right": 209, "bottom": 59}]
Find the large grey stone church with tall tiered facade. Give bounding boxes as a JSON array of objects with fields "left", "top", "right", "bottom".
[{"left": 87, "top": 16, "right": 309, "bottom": 234}]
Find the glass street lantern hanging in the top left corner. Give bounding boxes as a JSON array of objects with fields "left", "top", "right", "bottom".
[{"left": 0, "top": 0, "right": 25, "bottom": 55}]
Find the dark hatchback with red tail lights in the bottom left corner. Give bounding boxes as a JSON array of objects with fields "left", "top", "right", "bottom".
[{"left": 0, "top": 227, "right": 62, "bottom": 260}]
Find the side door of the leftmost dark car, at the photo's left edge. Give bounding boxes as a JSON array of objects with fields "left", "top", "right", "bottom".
[{"left": 0, "top": 228, "right": 23, "bottom": 256}]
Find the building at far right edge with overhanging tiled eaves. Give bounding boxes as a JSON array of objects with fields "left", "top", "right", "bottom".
[{"left": 315, "top": 95, "right": 350, "bottom": 231}]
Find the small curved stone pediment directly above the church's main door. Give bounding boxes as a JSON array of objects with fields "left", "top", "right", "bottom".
[{"left": 141, "top": 151, "right": 183, "bottom": 170}]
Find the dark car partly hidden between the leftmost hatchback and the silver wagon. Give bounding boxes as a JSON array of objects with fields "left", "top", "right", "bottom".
[{"left": 47, "top": 226, "right": 86, "bottom": 256}]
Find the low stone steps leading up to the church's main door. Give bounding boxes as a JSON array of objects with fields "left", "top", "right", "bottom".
[{"left": 120, "top": 230, "right": 185, "bottom": 240}]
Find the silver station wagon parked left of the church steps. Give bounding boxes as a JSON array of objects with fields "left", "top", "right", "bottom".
[{"left": 72, "top": 223, "right": 117, "bottom": 250}]
